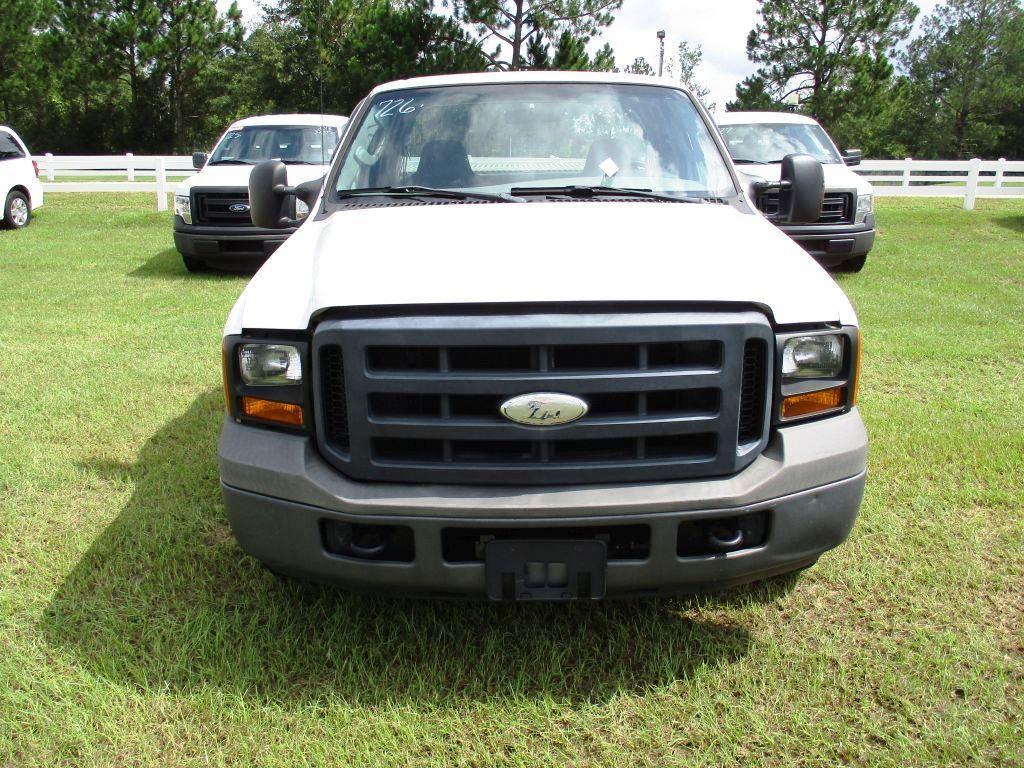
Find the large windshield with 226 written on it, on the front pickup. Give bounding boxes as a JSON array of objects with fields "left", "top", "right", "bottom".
[{"left": 335, "top": 83, "right": 735, "bottom": 198}]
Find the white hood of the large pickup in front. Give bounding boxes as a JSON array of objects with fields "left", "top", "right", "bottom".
[{"left": 225, "top": 201, "right": 856, "bottom": 334}]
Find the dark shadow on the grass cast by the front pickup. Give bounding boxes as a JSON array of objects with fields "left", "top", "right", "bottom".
[{"left": 41, "top": 392, "right": 793, "bottom": 707}]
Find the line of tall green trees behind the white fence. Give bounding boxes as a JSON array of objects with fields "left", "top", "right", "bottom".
[{"left": 0, "top": 0, "right": 1024, "bottom": 158}]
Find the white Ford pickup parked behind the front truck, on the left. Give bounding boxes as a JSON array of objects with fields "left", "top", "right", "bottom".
[{"left": 174, "top": 115, "right": 348, "bottom": 272}]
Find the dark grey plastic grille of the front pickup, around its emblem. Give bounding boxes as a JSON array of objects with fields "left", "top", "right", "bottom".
[{"left": 313, "top": 312, "right": 772, "bottom": 484}]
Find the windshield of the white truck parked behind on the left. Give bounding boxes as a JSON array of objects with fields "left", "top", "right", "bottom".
[{"left": 210, "top": 125, "right": 338, "bottom": 165}]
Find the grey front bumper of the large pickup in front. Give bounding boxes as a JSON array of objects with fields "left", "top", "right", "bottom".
[{"left": 219, "top": 410, "right": 867, "bottom": 598}]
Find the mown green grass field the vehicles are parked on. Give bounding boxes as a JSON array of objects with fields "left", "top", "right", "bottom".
[{"left": 0, "top": 194, "right": 1024, "bottom": 767}]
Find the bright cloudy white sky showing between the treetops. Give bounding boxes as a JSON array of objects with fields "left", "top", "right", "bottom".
[{"left": 218, "top": 0, "right": 939, "bottom": 109}]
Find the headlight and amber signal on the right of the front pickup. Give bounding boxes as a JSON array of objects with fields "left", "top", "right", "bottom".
[{"left": 775, "top": 327, "right": 860, "bottom": 422}]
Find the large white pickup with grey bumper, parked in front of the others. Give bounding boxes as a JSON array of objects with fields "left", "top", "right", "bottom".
[{"left": 219, "top": 73, "right": 867, "bottom": 600}]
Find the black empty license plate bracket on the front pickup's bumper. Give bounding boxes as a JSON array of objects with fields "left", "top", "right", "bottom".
[{"left": 484, "top": 539, "right": 608, "bottom": 600}]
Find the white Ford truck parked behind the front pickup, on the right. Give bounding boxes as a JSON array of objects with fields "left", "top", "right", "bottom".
[{"left": 716, "top": 112, "right": 874, "bottom": 272}]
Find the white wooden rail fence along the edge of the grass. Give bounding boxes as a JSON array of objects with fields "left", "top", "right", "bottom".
[{"left": 33, "top": 153, "right": 1024, "bottom": 211}]
